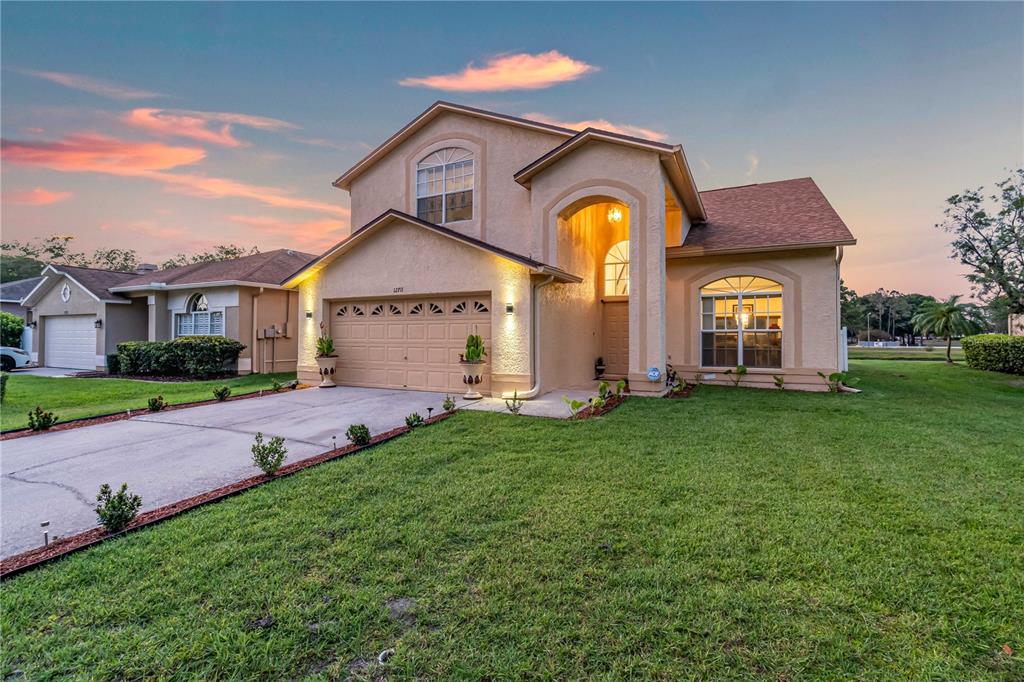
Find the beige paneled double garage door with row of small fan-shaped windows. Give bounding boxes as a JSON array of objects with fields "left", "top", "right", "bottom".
[{"left": 331, "top": 294, "right": 490, "bottom": 392}]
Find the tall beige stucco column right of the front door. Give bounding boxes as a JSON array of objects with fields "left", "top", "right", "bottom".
[{"left": 630, "top": 194, "right": 666, "bottom": 394}]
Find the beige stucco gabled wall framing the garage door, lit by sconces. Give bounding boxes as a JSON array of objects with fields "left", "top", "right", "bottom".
[{"left": 298, "top": 219, "right": 531, "bottom": 393}]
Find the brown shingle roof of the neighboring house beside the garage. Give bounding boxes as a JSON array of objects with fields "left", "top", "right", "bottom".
[{"left": 112, "top": 249, "right": 315, "bottom": 290}]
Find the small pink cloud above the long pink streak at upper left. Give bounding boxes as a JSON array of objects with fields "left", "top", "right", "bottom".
[{"left": 121, "top": 109, "right": 298, "bottom": 146}]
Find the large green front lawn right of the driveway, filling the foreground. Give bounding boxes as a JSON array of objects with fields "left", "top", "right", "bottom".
[{"left": 0, "top": 360, "right": 1024, "bottom": 680}]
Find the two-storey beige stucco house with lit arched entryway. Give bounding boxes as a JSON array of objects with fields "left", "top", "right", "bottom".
[{"left": 285, "top": 102, "right": 856, "bottom": 397}]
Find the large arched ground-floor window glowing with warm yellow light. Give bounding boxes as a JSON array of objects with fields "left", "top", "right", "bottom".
[{"left": 700, "top": 275, "right": 782, "bottom": 368}]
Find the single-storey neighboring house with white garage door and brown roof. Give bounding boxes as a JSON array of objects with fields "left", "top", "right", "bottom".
[{"left": 25, "top": 249, "right": 312, "bottom": 374}]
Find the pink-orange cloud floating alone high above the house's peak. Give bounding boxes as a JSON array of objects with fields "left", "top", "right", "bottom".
[{"left": 398, "top": 50, "right": 598, "bottom": 92}]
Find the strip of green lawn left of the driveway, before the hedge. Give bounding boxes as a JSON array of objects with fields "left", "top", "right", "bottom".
[{"left": 0, "top": 372, "right": 295, "bottom": 431}]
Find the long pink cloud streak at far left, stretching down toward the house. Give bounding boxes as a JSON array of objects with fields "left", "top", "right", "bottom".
[{"left": 0, "top": 134, "right": 348, "bottom": 217}]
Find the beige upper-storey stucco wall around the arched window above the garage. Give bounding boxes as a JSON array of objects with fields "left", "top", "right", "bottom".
[{"left": 351, "top": 113, "right": 565, "bottom": 256}]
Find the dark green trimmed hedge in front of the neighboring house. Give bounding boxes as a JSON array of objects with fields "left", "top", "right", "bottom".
[{"left": 116, "top": 336, "right": 245, "bottom": 377}]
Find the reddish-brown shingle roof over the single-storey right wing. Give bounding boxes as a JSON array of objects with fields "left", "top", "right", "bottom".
[{"left": 676, "top": 177, "right": 856, "bottom": 255}]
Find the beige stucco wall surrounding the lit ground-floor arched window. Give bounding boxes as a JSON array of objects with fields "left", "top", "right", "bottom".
[{"left": 666, "top": 248, "right": 839, "bottom": 390}]
